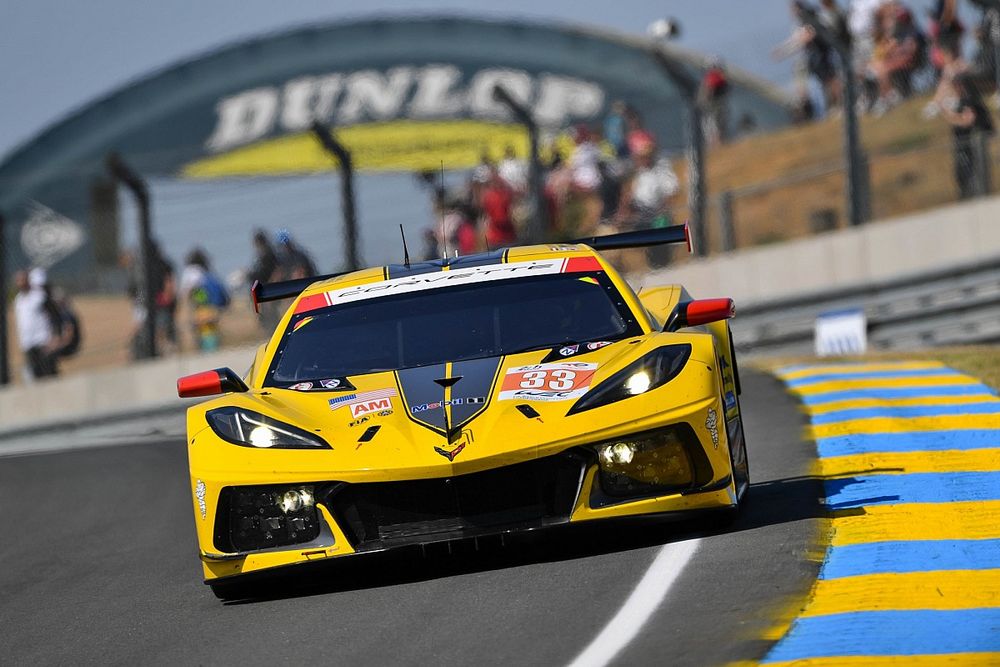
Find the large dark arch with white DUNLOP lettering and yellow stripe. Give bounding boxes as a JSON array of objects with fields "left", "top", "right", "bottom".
[{"left": 0, "top": 17, "right": 788, "bottom": 276}]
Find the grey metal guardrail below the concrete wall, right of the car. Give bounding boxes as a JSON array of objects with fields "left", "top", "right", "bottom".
[{"left": 733, "top": 257, "right": 1000, "bottom": 355}]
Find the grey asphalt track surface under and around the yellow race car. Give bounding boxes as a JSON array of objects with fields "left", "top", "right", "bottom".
[{"left": 0, "top": 372, "right": 822, "bottom": 665}]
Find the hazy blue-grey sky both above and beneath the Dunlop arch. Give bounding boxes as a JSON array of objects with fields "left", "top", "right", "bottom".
[{"left": 0, "top": 0, "right": 974, "bottom": 274}]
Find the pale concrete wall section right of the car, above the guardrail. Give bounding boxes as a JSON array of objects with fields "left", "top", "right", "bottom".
[{"left": 641, "top": 197, "right": 1000, "bottom": 306}]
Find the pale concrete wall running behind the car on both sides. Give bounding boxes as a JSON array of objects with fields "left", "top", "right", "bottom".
[{"left": 0, "top": 197, "right": 1000, "bottom": 434}]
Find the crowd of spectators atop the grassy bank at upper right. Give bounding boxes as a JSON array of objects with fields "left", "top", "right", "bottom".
[{"left": 774, "top": 0, "right": 1000, "bottom": 199}]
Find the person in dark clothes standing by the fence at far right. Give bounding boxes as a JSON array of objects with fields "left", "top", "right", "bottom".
[{"left": 944, "top": 73, "right": 993, "bottom": 199}]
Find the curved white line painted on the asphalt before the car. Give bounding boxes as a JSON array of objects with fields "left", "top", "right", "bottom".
[{"left": 569, "top": 539, "right": 701, "bottom": 667}]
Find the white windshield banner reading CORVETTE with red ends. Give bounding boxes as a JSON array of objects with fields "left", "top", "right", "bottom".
[{"left": 295, "top": 257, "right": 601, "bottom": 313}]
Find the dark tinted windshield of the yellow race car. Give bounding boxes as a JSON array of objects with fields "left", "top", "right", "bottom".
[{"left": 268, "top": 271, "right": 642, "bottom": 386}]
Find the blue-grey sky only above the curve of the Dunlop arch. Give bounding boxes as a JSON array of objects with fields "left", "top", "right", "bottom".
[{"left": 0, "top": 0, "right": 791, "bottom": 160}]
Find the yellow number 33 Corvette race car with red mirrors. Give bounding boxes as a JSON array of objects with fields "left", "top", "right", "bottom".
[{"left": 177, "top": 225, "right": 749, "bottom": 598}]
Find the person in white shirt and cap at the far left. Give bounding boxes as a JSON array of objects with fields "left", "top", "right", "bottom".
[{"left": 14, "top": 268, "right": 59, "bottom": 382}]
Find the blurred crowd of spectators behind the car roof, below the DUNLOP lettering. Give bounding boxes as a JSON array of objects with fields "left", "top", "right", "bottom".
[{"left": 422, "top": 104, "right": 684, "bottom": 259}]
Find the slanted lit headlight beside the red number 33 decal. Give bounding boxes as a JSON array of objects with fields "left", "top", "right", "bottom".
[{"left": 566, "top": 344, "right": 691, "bottom": 415}]
